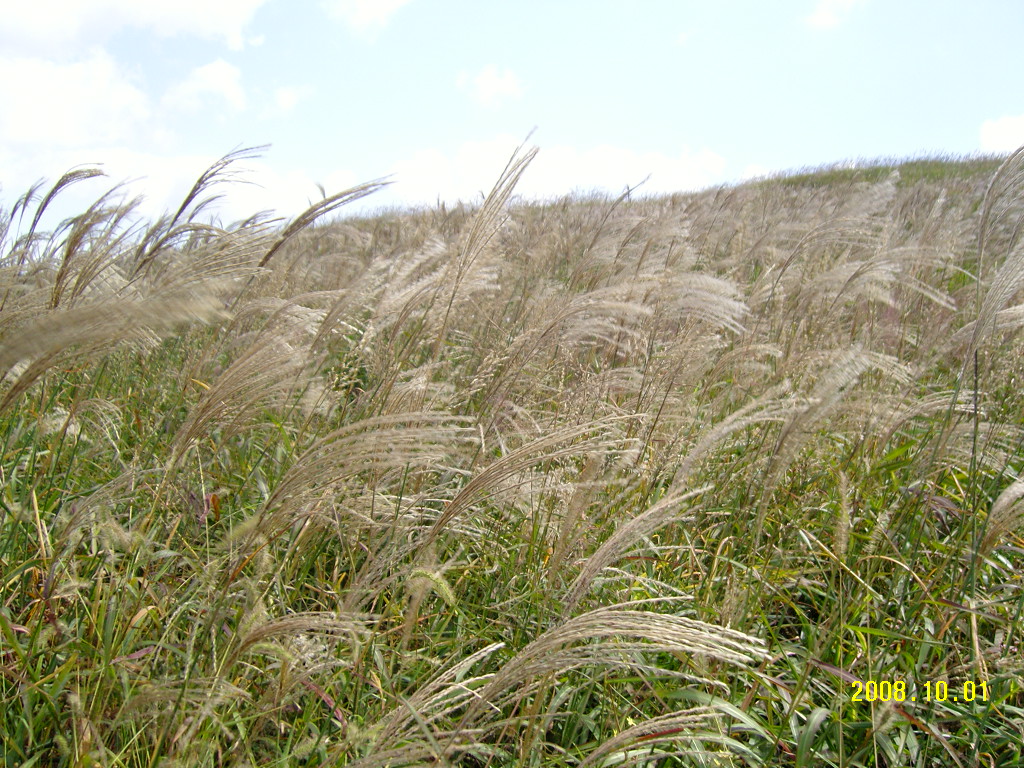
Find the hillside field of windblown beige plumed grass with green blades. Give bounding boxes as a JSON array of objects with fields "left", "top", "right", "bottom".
[{"left": 0, "top": 143, "right": 1024, "bottom": 768}]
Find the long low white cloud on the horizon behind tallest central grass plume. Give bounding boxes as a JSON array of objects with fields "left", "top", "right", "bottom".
[{"left": 389, "top": 135, "right": 725, "bottom": 204}]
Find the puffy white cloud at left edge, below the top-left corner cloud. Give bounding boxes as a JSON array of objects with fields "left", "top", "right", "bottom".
[{"left": 0, "top": 50, "right": 150, "bottom": 151}]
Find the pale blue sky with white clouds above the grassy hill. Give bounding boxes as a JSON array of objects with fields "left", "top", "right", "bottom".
[{"left": 0, "top": 0, "right": 1024, "bottom": 221}]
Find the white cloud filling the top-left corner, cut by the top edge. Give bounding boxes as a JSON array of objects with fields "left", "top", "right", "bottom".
[{"left": 0, "top": 0, "right": 267, "bottom": 55}]
